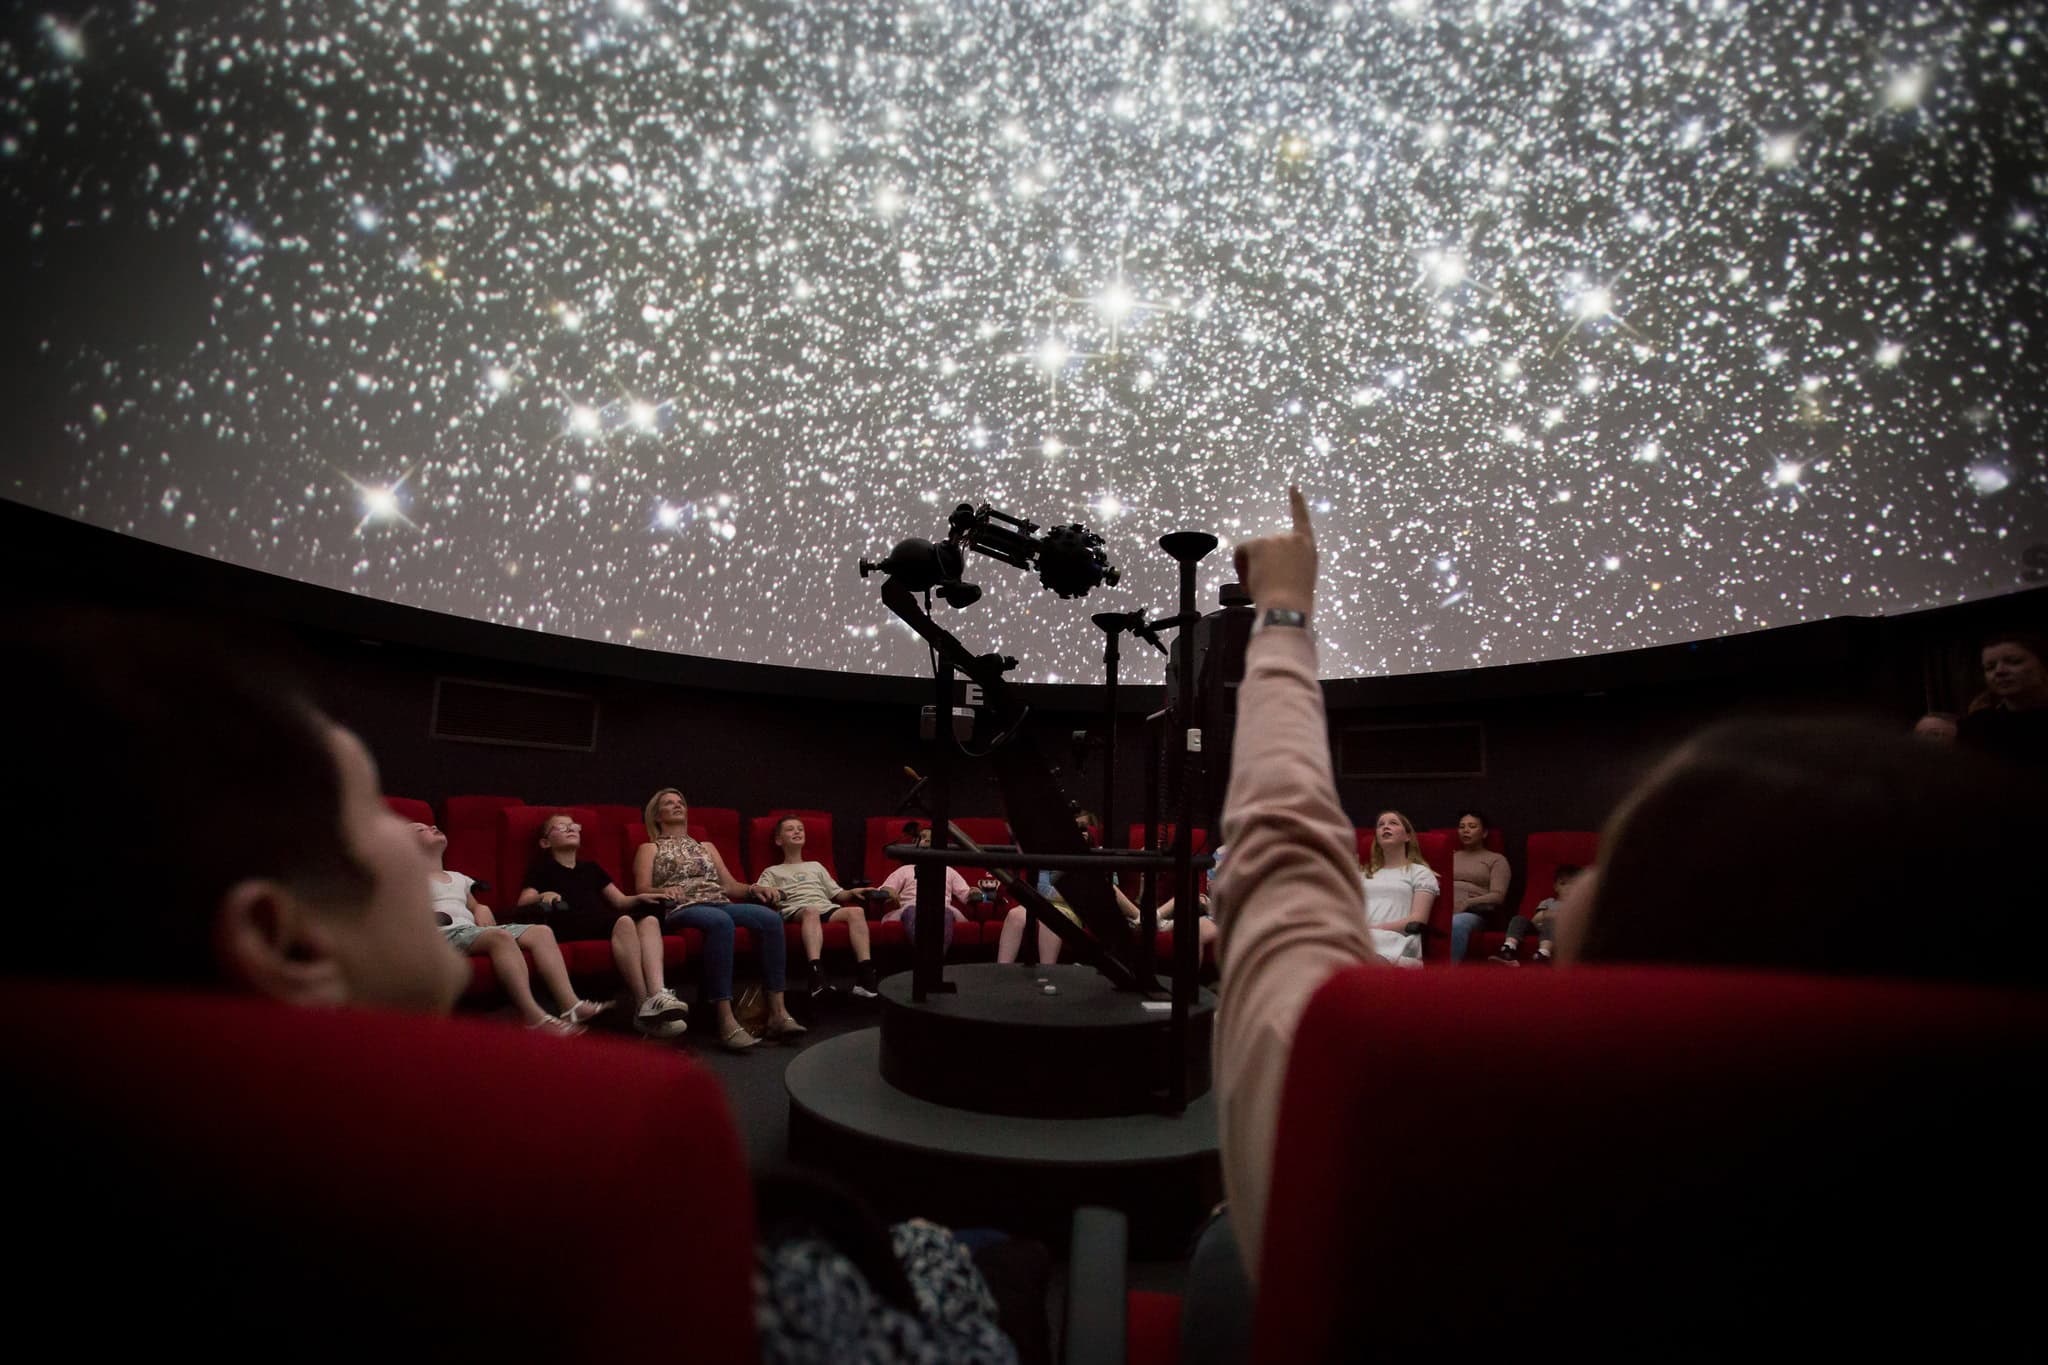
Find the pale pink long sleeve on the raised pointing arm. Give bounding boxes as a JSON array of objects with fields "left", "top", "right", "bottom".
[{"left": 1214, "top": 626, "right": 1378, "bottom": 1281}]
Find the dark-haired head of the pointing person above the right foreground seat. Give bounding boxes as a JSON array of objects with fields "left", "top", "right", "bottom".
[{"left": 1556, "top": 718, "right": 2048, "bottom": 984}]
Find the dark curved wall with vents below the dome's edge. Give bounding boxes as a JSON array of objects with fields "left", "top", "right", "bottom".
[{"left": 16, "top": 501, "right": 2048, "bottom": 892}]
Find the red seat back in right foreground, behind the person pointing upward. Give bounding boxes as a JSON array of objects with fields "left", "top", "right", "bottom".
[{"left": 1253, "top": 966, "right": 2048, "bottom": 1365}]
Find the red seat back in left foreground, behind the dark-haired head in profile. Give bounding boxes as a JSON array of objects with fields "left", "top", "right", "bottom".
[{"left": 0, "top": 982, "right": 758, "bottom": 1361}]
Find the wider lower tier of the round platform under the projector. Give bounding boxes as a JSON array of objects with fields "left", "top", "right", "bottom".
[{"left": 784, "top": 1023, "right": 1223, "bottom": 1257}]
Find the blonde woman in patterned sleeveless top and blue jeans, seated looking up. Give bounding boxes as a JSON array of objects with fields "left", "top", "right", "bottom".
[{"left": 633, "top": 786, "right": 805, "bottom": 1052}]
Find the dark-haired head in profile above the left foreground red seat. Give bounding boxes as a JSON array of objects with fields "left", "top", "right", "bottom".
[{"left": 0, "top": 612, "right": 469, "bottom": 1011}]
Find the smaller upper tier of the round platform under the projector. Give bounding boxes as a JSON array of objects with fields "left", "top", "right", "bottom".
[{"left": 881, "top": 962, "right": 1217, "bottom": 1119}]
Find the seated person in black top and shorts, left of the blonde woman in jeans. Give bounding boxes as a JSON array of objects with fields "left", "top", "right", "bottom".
[{"left": 518, "top": 810, "right": 690, "bottom": 1038}]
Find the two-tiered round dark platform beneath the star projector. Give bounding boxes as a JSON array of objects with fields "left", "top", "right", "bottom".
[{"left": 784, "top": 964, "right": 1223, "bottom": 1259}]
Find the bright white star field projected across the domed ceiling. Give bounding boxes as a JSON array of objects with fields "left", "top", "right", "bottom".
[{"left": 0, "top": 0, "right": 2048, "bottom": 679}]
